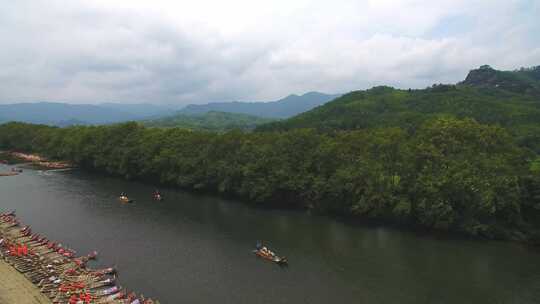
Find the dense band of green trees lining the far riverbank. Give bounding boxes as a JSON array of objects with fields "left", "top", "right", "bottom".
[{"left": 0, "top": 117, "right": 540, "bottom": 242}]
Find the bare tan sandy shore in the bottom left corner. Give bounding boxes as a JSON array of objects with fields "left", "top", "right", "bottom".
[{"left": 0, "top": 259, "right": 52, "bottom": 304}]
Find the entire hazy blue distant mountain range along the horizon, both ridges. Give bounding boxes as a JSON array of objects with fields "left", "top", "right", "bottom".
[{"left": 0, "top": 92, "right": 339, "bottom": 127}]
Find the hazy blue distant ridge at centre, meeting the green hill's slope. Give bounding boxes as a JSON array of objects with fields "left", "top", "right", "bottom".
[{"left": 180, "top": 92, "right": 341, "bottom": 118}]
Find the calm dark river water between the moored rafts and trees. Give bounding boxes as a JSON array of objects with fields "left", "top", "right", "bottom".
[{"left": 0, "top": 165, "right": 540, "bottom": 304}]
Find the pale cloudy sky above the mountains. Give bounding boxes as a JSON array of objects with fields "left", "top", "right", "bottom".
[{"left": 0, "top": 0, "right": 540, "bottom": 105}]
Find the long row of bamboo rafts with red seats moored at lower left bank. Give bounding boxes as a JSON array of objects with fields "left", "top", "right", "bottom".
[{"left": 0, "top": 212, "right": 159, "bottom": 304}]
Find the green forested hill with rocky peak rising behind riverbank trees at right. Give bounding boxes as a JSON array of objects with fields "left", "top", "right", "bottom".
[{"left": 257, "top": 66, "right": 540, "bottom": 151}]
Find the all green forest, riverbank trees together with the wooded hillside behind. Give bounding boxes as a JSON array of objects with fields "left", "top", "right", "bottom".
[{"left": 0, "top": 65, "right": 540, "bottom": 243}]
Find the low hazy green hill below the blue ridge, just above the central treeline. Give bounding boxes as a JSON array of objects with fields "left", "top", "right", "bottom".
[{"left": 142, "top": 111, "right": 273, "bottom": 131}]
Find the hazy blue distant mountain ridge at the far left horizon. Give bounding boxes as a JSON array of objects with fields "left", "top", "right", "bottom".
[{"left": 0, "top": 102, "right": 171, "bottom": 126}]
